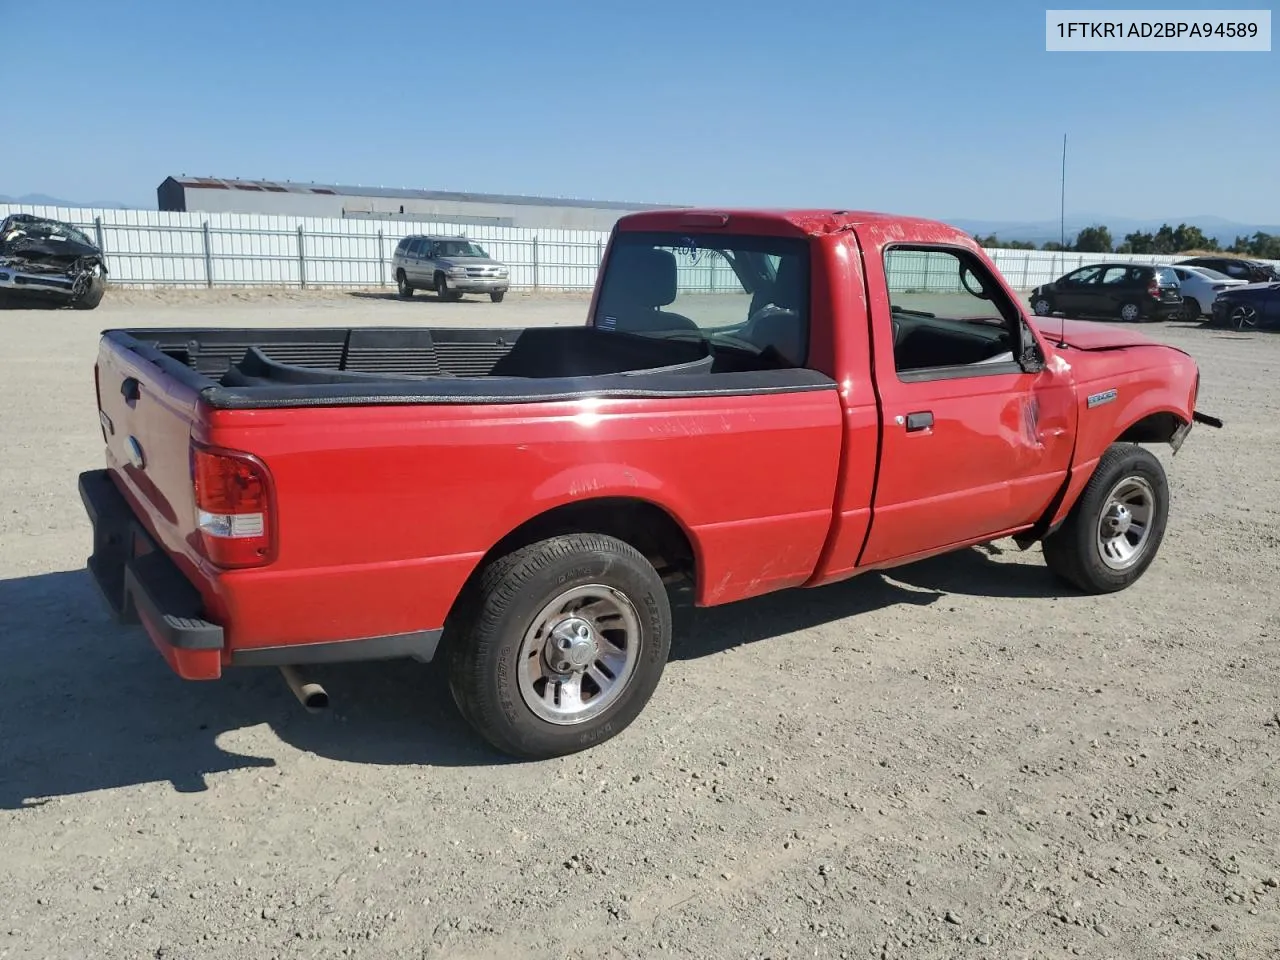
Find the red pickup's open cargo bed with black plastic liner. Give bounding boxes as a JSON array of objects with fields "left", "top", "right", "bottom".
[{"left": 104, "top": 325, "right": 832, "bottom": 408}]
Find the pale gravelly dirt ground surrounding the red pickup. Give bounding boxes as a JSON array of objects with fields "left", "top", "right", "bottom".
[{"left": 0, "top": 292, "right": 1280, "bottom": 960}]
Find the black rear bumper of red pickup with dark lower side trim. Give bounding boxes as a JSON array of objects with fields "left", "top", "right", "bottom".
[{"left": 79, "top": 470, "right": 443, "bottom": 680}]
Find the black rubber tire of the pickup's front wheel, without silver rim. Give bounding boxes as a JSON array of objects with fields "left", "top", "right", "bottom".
[{"left": 1042, "top": 443, "right": 1170, "bottom": 594}]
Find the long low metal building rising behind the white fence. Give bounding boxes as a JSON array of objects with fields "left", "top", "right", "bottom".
[{"left": 156, "top": 177, "right": 673, "bottom": 230}]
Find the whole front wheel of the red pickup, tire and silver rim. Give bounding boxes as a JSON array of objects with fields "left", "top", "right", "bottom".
[{"left": 1042, "top": 443, "right": 1169, "bottom": 594}]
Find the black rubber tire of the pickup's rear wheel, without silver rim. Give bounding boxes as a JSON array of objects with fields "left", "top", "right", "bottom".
[{"left": 444, "top": 534, "right": 672, "bottom": 760}]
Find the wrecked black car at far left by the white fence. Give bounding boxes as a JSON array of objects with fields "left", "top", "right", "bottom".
[{"left": 0, "top": 214, "right": 106, "bottom": 310}]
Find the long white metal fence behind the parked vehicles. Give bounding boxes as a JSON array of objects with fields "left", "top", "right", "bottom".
[{"left": 0, "top": 204, "right": 1274, "bottom": 292}]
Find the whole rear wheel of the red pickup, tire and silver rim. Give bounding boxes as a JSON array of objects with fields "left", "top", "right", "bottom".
[{"left": 445, "top": 534, "right": 671, "bottom": 759}]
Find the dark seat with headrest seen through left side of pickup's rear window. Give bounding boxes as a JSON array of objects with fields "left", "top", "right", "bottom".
[{"left": 595, "top": 244, "right": 698, "bottom": 333}]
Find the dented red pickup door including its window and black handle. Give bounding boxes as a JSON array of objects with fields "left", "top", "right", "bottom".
[{"left": 858, "top": 240, "right": 1074, "bottom": 567}]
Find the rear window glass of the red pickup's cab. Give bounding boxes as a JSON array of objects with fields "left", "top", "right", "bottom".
[{"left": 593, "top": 232, "right": 809, "bottom": 366}]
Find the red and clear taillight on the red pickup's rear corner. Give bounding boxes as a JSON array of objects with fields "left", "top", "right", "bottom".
[{"left": 191, "top": 443, "right": 275, "bottom": 567}]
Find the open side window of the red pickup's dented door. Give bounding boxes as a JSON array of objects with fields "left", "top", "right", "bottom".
[{"left": 884, "top": 246, "right": 1024, "bottom": 380}]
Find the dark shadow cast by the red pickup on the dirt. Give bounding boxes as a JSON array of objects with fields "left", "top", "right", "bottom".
[{"left": 0, "top": 548, "right": 1059, "bottom": 809}]
